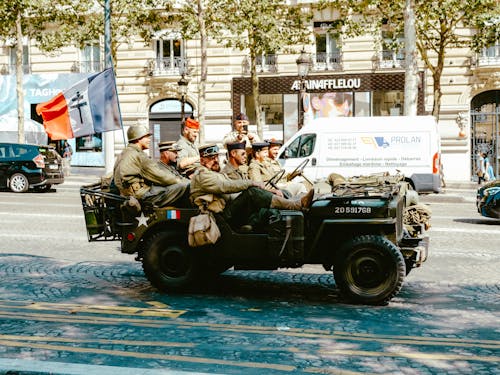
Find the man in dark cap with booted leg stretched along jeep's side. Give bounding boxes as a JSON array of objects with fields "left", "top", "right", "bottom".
[{"left": 191, "top": 145, "right": 314, "bottom": 231}]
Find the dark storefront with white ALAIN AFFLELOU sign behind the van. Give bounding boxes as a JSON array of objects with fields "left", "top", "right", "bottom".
[{"left": 232, "top": 72, "right": 424, "bottom": 140}]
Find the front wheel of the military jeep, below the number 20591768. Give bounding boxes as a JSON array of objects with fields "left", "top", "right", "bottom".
[{"left": 333, "top": 235, "right": 406, "bottom": 305}]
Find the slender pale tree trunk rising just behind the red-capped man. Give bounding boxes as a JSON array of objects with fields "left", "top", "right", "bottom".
[{"left": 198, "top": 0, "right": 208, "bottom": 144}]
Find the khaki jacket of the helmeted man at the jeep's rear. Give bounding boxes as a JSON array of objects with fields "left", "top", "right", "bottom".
[{"left": 113, "top": 143, "right": 182, "bottom": 198}]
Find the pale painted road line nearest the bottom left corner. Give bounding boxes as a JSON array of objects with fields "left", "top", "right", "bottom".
[{"left": 0, "top": 340, "right": 297, "bottom": 371}]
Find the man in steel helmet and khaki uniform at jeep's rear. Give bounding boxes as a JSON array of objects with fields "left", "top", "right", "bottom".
[{"left": 113, "top": 125, "right": 190, "bottom": 207}]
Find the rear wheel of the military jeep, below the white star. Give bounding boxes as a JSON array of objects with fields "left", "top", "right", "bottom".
[{"left": 142, "top": 232, "right": 197, "bottom": 292}]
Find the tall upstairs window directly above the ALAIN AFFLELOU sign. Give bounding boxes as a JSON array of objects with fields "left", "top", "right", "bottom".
[{"left": 314, "top": 22, "right": 342, "bottom": 70}]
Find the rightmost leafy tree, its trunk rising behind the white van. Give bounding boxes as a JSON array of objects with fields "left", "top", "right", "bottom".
[{"left": 322, "top": 0, "right": 500, "bottom": 119}]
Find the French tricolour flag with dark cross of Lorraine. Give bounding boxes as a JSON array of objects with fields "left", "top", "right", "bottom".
[{"left": 36, "top": 68, "right": 121, "bottom": 140}]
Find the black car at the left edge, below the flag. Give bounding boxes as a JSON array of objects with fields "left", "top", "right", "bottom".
[{"left": 0, "top": 143, "right": 64, "bottom": 193}]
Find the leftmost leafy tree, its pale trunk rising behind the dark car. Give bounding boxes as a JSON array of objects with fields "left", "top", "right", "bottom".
[{"left": 0, "top": 0, "right": 87, "bottom": 143}]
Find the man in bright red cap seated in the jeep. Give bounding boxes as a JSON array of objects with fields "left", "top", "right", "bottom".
[{"left": 177, "top": 118, "right": 200, "bottom": 175}]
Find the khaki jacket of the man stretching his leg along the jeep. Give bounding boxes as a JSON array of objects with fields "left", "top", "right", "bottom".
[{"left": 190, "top": 166, "right": 253, "bottom": 206}]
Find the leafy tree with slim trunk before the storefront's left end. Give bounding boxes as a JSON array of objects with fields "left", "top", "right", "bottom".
[{"left": 210, "top": 0, "right": 312, "bottom": 138}]
